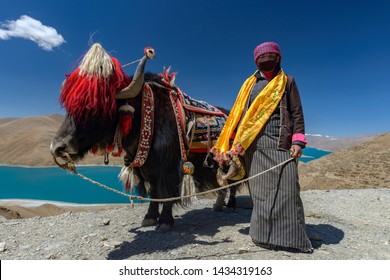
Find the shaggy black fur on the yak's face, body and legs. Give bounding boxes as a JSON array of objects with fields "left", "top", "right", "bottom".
[{"left": 53, "top": 73, "right": 226, "bottom": 230}]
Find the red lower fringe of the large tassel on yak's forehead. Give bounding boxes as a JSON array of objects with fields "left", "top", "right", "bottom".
[{"left": 60, "top": 57, "right": 131, "bottom": 123}]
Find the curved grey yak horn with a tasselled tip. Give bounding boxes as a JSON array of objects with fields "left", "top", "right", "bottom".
[{"left": 115, "top": 47, "right": 154, "bottom": 99}]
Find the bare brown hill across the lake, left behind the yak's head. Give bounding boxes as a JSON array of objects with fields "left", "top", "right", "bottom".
[{"left": 0, "top": 114, "right": 122, "bottom": 166}]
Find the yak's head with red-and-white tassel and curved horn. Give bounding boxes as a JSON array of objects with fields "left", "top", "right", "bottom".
[{"left": 50, "top": 44, "right": 154, "bottom": 161}]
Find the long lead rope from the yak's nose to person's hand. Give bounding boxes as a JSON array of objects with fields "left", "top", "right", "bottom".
[{"left": 53, "top": 153, "right": 295, "bottom": 203}]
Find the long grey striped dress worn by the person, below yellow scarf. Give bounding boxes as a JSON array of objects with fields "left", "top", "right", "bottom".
[{"left": 245, "top": 111, "right": 312, "bottom": 251}]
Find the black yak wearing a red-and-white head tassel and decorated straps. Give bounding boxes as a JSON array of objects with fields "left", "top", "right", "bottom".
[{"left": 50, "top": 44, "right": 236, "bottom": 231}]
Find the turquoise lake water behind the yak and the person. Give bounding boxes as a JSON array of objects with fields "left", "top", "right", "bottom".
[{"left": 0, "top": 148, "right": 330, "bottom": 204}]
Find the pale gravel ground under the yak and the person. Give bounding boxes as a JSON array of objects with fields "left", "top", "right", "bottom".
[{"left": 0, "top": 189, "right": 390, "bottom": 260}]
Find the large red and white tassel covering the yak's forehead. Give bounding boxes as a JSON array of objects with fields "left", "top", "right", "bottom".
[{"left": 60, "top": 44, "right": 131, "bottom": 124}]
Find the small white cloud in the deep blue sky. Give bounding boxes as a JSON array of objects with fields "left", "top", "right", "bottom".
[{"left": 0, "top": 15, "right": 65, "bottom": 51}]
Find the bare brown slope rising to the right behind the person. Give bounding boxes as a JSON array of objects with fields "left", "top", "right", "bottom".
[{"left": 299, "top": 133, "right": 390, "bottom": 190}]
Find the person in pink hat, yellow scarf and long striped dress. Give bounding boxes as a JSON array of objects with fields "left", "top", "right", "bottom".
[{"left": 212, "top": 42, "right": 313, "bottom": 253}]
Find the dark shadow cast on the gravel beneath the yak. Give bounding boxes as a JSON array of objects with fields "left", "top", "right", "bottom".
[{"left": 107, "top": 208, "right": 252, "bottom": 260}]
